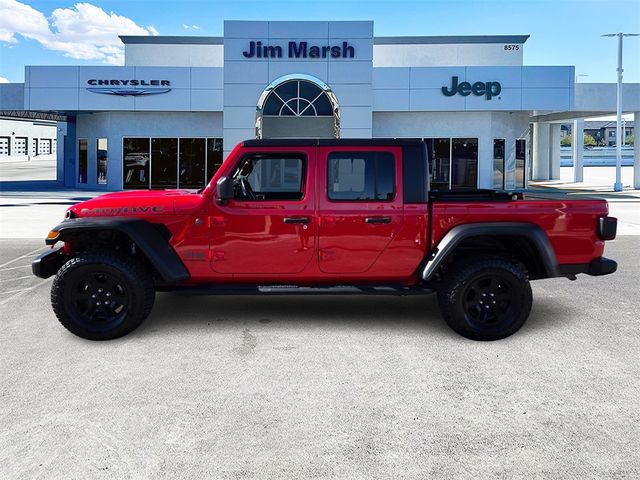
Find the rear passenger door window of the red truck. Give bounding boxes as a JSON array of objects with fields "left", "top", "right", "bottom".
[{"left": 327, "top": 152, "right": 396, "bottom": 201}]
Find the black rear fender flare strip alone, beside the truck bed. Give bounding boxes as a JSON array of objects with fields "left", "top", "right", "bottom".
[{"left": 418, "top": 222, "right": 561, "bottom": 280}]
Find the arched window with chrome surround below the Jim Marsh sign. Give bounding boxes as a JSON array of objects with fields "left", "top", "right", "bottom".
[{"left": 256, "top": 75, "right": 340, "bottom": 138}]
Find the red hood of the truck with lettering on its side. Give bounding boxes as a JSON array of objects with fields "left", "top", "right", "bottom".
[{"left": 69, "top": 190, "right": 192, "bottom": 217}]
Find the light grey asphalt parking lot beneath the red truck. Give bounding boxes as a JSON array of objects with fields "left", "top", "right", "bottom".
[{"left": 0, "top": 236, "right": 640, "bottom": 479}]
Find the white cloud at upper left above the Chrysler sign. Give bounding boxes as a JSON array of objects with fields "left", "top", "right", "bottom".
[{"left": 0, "top": 0, "right": 158, "bottom": 65}]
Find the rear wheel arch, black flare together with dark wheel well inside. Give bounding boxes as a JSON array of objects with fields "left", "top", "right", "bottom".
[{"left": 418, "top": 222, "right": 560, "bottom": 281}]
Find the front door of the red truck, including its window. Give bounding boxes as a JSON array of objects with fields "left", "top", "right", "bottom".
[{"left": 211, "top": 147, "right": 316, "bottom": 274}]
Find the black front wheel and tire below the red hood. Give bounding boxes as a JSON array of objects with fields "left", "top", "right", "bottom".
[{"left": 51, "top": 251, "right": 155, "bottom": 340}]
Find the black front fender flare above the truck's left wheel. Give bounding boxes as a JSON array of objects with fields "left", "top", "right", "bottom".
[{"left": 46, "top": 217, "right": 190, "bottom": 283}]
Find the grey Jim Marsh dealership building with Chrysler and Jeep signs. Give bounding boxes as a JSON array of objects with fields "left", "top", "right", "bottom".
[{"left": 0, "top": 21, "right": 640, "bottom": 190}]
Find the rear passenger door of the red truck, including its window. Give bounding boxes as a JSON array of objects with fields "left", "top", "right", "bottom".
[{"left": 317, "top": 146, "right": 403, "bottom": 274}]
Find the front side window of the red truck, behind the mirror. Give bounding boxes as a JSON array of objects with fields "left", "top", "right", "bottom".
[{"left": 232, "top": 154, "right": 306, "bottom": 201}]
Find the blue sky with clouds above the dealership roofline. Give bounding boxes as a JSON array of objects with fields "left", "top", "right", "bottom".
[{"left": 0, "top": 0, "right": 640, "bottom": 82}]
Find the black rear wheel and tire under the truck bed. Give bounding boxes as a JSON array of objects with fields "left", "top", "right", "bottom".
[{"left": 438, "top": 257, "right": 532, "bottom": 340}]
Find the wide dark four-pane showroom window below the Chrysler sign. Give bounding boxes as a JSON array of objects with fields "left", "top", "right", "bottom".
[{"left": 122, "top": 137, "right": 222, "bottom": 189}]
